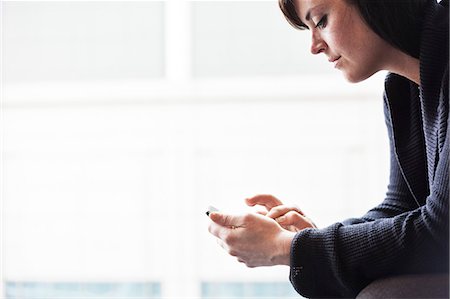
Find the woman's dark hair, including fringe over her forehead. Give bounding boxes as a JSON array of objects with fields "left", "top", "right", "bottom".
[{"left": 278, "top": 0, "right": 428, "bottom": 58}]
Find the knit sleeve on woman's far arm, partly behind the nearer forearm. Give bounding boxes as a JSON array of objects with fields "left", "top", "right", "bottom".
[{"left": 342, "top": 96, "right": 417, "bottom": 225}]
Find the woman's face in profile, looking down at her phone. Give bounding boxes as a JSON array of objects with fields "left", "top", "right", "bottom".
[{"left": 295, "top": 0, "right": 390, "bottom": 82}]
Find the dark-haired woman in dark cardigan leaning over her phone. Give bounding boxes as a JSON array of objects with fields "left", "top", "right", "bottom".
[{"left": 209, "top": 0, "right": 450, "bottom": 297}]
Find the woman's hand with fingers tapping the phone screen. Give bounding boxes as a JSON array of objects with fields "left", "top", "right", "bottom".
[{"left": 246, "top": 195, "right": 317, "bottom": 232}]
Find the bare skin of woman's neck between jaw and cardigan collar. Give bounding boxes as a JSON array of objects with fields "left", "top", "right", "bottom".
[{"left": 386, "top": 49, "right": 420, "bottom": 85}]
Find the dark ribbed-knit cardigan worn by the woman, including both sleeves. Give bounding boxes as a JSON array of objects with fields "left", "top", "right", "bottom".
[{"left": 290, "top": 0, "right": 450, "bottom": 297}]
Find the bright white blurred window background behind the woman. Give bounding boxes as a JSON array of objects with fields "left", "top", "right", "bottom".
[{"left": 0, "top": 0, "right": 388, "bottom": 299}]
